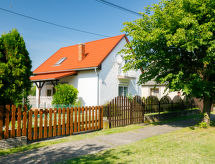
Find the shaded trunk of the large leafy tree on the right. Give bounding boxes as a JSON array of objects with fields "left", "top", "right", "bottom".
[{"left": 202, "top": 97, "right": 213, "bottom": 125}]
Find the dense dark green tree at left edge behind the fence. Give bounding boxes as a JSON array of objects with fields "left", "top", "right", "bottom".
[{"left": 0, "top": 29, "right": 32, "bottom": 105}]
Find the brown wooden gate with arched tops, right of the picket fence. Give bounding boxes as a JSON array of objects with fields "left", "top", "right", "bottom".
[{"left": 107, "top": 96, "right": 144, "bottom": 128}]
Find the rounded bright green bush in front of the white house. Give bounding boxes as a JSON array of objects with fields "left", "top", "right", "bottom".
[{"left": 52, "top": 84, "right": 78, "bottom": 105}]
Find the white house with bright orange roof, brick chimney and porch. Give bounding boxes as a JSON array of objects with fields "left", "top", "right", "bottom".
[{"left": 31, "top": 35, "right": 142, "bottom": 107}]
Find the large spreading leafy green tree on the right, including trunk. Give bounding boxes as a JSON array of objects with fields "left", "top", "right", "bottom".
[{"left": 121, "top": 0, "right": 215, "bottom": 123}]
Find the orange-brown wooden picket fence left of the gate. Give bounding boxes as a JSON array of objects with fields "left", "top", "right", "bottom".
[{"left": 0, "top": 105, "right": 103, "bottom": 141}]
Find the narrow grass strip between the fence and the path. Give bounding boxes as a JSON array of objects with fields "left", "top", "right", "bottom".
[{"left": 0, "top": 114, "right": 202, "bottom": 156}]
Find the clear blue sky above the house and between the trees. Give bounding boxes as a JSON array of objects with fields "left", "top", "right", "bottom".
[{"left": 0, "top": 0, "right": 159, "bottom": 70}]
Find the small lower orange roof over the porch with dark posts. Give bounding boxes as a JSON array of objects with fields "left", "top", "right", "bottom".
[{"left": 30, "top": 71, "right": 77, "bottom": 81}]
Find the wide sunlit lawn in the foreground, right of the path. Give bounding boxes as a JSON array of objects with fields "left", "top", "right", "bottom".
[{"left": 62, "top": 127, "right": 215, "bottom": 164}]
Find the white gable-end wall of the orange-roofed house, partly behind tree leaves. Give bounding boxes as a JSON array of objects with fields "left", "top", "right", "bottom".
[{"left": 99, "top": 39, "right": 141, "bottom": 105}]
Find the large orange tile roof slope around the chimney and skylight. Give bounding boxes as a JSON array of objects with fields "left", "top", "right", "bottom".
[{"left": 33, "top": 34, "right": 127, "bottom": 74}]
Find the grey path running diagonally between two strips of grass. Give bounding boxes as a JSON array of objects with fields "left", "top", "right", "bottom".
[{"left": 0, "top": 120, "right": 196, "bottom": 164}]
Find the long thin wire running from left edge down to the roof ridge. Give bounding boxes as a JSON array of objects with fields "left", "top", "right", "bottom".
[{"left": 0, "top": 7, "right": 110, "bottom": 37}]
